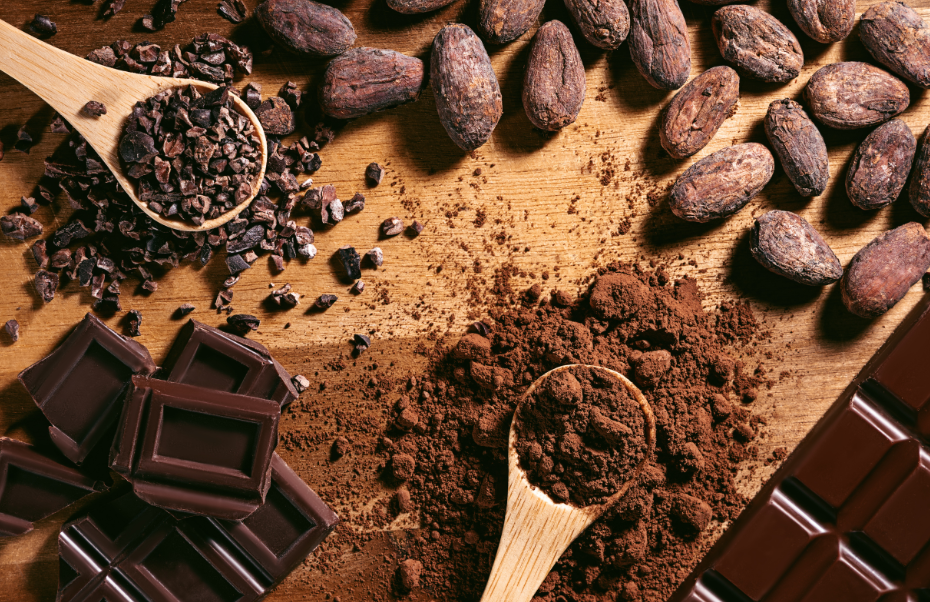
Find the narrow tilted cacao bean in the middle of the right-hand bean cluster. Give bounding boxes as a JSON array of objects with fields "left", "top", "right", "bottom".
[{"left": 765, "top": 98, "right": 830, "bottom": 197}]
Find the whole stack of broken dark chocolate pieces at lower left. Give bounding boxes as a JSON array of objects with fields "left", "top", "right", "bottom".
[{"left": 0, "top": 314, "right": 339, "bottom": 602}]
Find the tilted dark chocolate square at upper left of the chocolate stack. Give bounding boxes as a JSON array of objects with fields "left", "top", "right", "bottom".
[{"left": 19, "top": 314, "right": 155, "bottom": 464}]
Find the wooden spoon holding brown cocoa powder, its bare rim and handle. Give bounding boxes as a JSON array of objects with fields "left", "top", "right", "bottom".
[{"left": 481, "top": 364, "right": 656, "bottom": 602}]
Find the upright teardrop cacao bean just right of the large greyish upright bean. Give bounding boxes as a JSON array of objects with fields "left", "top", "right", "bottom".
[{"left": 523, "top": 21, "right": 585, "bottom": 131}]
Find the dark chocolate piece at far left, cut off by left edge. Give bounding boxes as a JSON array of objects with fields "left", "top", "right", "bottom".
[{"left": 0, "top": 437, "right": 103, "bottom": 537}]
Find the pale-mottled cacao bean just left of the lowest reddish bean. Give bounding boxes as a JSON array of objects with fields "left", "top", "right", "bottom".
[{"left": 749, "top": 210, "right": 843, "bottom": 286}]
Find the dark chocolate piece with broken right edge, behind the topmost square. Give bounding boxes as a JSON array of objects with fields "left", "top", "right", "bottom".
[{"left": 163, "top": 320, "right": 298, "bottom": 407}]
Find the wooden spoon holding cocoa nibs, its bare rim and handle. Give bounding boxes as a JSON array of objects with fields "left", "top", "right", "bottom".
[{"left": 0, "top": 20, "right": 268, "bottom": 232}]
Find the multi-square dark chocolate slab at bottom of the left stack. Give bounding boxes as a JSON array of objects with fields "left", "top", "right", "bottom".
[{"left": 57, "top": 454, "right": 339, "bottom": 602}]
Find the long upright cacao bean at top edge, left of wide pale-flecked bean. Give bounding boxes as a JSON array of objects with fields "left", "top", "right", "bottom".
[{"left": 630, "top": 0, "right": 691, "bottom": 90}]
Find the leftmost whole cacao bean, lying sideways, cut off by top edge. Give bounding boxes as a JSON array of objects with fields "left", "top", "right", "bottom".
[{"left": 255, "top": 0, "right": 356, "bottom": 56}]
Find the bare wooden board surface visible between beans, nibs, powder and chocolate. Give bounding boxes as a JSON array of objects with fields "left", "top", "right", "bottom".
[{"left": 0, "top": 0, "right": 930, "bottom": 601}]
